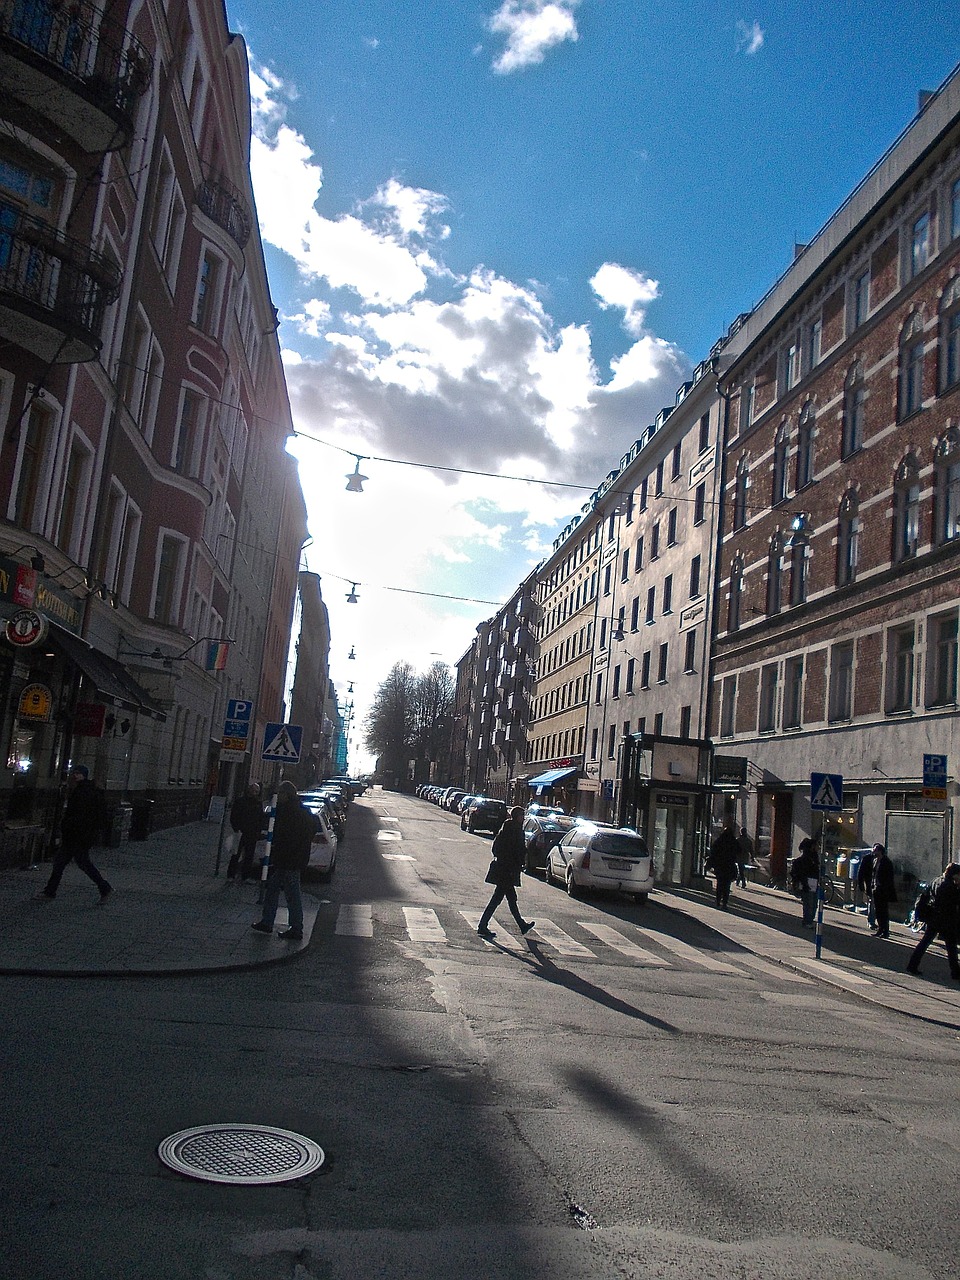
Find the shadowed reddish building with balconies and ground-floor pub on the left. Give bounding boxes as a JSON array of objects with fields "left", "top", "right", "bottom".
[{"left": 0, "top": 0, "right": 306, "bottom": 861}]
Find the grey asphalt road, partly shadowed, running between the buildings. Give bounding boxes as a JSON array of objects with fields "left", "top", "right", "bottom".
[{"left": 0, "top": 792, "right": 960, "bottom": 1280}]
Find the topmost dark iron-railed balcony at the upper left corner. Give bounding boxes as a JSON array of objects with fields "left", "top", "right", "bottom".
[{"left": 0, "top": 0, "right": 154, "bottom": 154}]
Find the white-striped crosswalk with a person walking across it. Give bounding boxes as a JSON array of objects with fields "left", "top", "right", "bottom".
[{"left": 327, "top": 902, "right": 813, "bottom": 986}]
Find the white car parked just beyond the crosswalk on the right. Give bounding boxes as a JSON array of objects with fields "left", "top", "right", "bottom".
[{"left": 547, "top": 822, "right": 653, "bottom": 902}]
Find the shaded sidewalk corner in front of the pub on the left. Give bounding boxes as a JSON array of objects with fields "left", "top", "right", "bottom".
[{"left": 0, "top": 822, "right": 320, "bottom": 977}]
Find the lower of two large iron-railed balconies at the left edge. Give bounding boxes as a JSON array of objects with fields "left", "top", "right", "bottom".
[{"left": 0, "top": 206, "right": 120, "bottom": 365}]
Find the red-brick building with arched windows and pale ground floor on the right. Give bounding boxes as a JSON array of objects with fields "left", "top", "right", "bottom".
[{"left": 710, "top": 72, "right": 960, "bottom": 890}]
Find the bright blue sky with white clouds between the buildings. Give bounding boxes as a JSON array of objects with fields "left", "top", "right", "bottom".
[{"left": 227, "top": 0, "right": 960, "bottom": 772}]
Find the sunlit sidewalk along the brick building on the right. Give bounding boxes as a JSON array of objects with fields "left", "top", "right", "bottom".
[{"left": 655, "top": 884, "right": 960, "bottom": 1030}]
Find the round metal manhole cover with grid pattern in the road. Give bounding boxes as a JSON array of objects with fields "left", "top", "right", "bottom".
[{"left": 157, "top": 1124, "right": 324, "bottom": 1187}]
